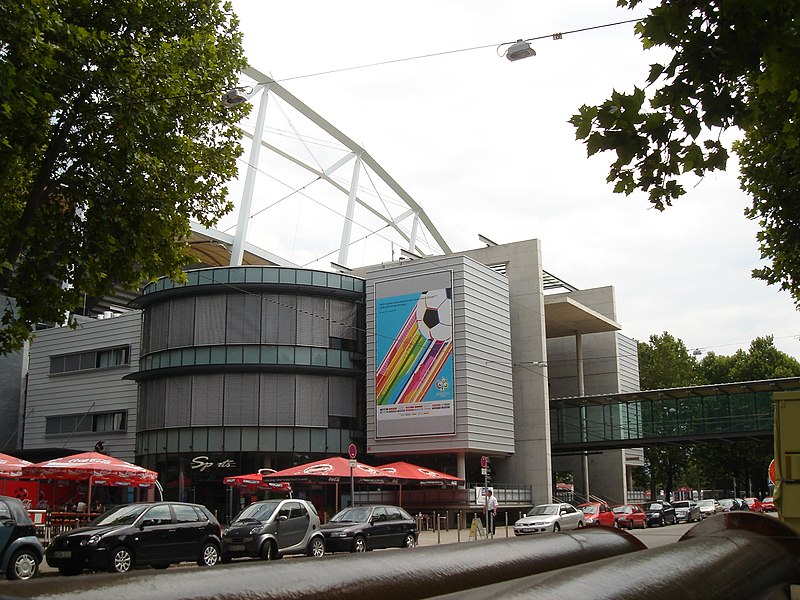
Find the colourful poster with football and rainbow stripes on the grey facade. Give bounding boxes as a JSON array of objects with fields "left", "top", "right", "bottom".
[{"left": 375, "top": 271, "right": 455, "bottom": 438}]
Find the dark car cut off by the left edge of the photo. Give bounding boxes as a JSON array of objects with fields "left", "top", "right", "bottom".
[{"left": 0, "top": 496, "right": 44, "bottom": 579}]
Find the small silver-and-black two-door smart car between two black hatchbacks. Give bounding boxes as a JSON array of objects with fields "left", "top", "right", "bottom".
[{"left": 222, "top": 499, "right": 325, "bottom": 562}]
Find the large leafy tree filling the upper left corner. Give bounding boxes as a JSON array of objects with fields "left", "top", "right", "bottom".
[{"left": 0, "top": 0, "right": 246, "bottom": 353}]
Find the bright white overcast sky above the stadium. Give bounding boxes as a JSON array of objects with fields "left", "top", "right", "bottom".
[{"left": 222, "top": 0, "right": 800, "bottom": 357}]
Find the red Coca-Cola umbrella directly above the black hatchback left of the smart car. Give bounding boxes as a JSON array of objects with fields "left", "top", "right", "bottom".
[{"left": 22, "top": 452, "right": 158, "bottom": 512}]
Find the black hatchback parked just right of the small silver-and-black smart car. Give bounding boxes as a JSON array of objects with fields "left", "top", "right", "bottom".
[{"left": 322, "top": 505, "right": 418, "bottom": 552}]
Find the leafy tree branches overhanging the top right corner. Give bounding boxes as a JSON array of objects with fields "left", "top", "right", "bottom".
[{"left": 570, "top": 0, "right": 800, "bottom": 306}]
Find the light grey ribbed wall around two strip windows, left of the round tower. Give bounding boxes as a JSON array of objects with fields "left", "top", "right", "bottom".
[{"left": 25, "top": 311, "right": 141, "bottom": 462}]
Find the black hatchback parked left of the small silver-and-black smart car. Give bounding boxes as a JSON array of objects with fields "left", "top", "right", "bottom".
[{"left": 46, "top": 502, "right": 222, "bottom": 575}]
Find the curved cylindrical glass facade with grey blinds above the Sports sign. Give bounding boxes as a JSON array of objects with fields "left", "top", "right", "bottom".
[{"left": 131, "top": 267, "right": 366, "bottom": 511}]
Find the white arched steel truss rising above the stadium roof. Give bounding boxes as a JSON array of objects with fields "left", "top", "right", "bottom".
[{"left": 231, "top": 67, "right": 451, "bottom": 268}]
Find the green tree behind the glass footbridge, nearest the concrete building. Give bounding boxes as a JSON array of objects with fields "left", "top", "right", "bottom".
[{"left": 638, "top": 331, "right": 699, "bottom": 498}]
